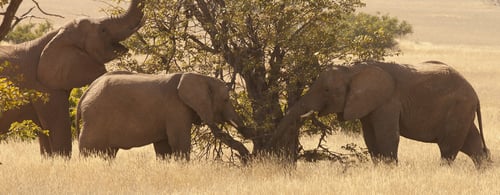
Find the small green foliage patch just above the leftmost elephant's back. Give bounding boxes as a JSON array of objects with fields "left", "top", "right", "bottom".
[{"left": 5, "top": 21, "right": 53, "bottom": 43}]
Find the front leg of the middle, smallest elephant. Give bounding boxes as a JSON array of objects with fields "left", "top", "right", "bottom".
[{"left": 166, "top": 120, "right": 192, "bottom": 160}]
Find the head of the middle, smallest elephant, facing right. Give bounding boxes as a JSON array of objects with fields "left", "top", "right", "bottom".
[{"left": 177, "top": 73, "right": 244, "bottom": 129}]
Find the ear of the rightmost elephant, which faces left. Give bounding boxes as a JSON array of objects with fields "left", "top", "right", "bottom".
[{"left": 344, "top": 66, "right": 395, "bottom": 120}]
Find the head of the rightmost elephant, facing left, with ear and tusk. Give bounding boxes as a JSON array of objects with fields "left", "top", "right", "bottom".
[{"left": 289, "top": 66, "right": 395, "bottom": 120}]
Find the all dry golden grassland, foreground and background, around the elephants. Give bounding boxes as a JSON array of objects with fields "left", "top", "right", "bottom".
[{"left": 0, "top": 0, "right": 500, "bottom": 194}]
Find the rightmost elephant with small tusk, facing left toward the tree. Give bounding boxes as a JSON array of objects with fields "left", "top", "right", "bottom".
[{"left": 278, "top": 61, "right": 489, "bottom": 166}]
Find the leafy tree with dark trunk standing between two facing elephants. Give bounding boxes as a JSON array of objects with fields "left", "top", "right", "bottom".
[{"left": 113, "top": 0, "right": 411, "bottom": 159}]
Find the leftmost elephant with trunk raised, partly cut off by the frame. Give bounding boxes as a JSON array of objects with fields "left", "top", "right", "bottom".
[{"left": 0, "top": 0, "right": 144, "bottom": 157}]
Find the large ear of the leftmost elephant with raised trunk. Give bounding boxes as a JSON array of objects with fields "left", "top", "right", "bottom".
[{"left": 37, "top": 28, "right": 106, "bottom": 89}]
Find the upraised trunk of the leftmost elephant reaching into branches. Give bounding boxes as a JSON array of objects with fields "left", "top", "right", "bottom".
[{"left": 102, "top": 0, "right": 145, "bottom": 42}]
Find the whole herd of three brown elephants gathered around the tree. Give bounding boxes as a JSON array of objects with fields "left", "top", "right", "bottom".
[{"left": 0, "top": 0, "right": 490, "bottom": 166}]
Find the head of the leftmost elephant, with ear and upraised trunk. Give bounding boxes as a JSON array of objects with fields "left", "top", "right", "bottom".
[{"left": 37, "top": 0, "right": 144, "bottom": 89}]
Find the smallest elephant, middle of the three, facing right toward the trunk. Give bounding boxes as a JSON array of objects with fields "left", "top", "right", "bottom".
[{"left": 78, "top": 72, "right": 244, "bottom": 160}]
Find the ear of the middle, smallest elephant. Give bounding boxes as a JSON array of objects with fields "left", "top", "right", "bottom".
[{"left": 177, "top": 73, "right": 214, "bottom": 124}]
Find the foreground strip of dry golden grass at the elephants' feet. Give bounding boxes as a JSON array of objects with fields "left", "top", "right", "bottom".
[{"left": 0, "top": 135, "right": 500, "bottom": 194}]
